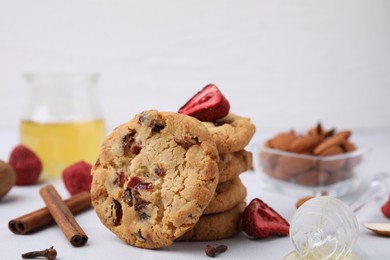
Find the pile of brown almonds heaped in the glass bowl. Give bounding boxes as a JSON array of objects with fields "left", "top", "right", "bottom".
[{"left": 260, "top": 123, "right": 361, "bottom": 186}]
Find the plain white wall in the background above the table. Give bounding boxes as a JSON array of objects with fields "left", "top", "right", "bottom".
[{"left": 0, "top": 0, "right": 390, "bottom": 131}]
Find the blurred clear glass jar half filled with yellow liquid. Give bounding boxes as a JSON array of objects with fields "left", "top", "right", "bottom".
[{"left": 20, "top": 74, "right": 105, "bottom": 179}]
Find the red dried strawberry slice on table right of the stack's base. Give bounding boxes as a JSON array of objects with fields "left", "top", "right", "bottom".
[{"left": 242, "top": 198, "right": 290, "bottom": 238}]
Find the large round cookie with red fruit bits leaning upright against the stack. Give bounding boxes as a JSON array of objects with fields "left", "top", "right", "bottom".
[{"left": 91, "top": 110, "right": 218, "bottom": 248}]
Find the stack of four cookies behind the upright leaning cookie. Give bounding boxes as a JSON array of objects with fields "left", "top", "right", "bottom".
[{"left": 176, "top": 113, "right": 255, "bottom": 241}]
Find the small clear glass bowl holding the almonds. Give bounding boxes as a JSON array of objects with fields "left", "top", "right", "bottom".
[{"left": 254, "top": 146, "right": 367, "bottom": 197}]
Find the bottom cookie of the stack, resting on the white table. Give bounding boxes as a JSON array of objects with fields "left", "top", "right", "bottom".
[{"left": 176, "top": 202, "right": 246, "bottom": 241}]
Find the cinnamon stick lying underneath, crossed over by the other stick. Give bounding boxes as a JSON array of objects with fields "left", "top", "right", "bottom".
[{"left": 8, "top": 191, "right": 91, "bottom": 235}]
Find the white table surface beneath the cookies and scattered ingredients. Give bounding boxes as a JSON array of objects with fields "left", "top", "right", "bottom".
[{"left": 0, "top": 130, "right": 390, "bottom": 260}]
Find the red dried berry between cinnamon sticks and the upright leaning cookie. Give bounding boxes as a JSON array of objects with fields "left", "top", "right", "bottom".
[{"left": 62, "top": 161, "right": 92, "bottom": 195}]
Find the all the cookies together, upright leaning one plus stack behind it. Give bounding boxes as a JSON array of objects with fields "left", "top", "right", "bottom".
[{"left": 91, "top": 110, "right": 255, "bottom": 248}]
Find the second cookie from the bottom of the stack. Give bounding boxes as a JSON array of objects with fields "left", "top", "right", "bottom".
[{"left": 203, "top": 178, "right": 246, "bottom": 214}]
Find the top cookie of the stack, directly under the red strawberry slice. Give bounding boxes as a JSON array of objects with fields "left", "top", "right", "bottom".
[{"left": 203, "top": 113, "right": 256, "bottom": 153}]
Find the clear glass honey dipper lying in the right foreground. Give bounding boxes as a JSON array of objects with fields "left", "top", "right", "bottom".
[{"left": 285, "top": 173, "right": 390, "bottom": 260}]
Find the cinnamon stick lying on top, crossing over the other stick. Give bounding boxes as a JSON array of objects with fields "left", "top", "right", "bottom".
[{"left": 39, "top": 184, "right": 88, "bottom": 247}]
